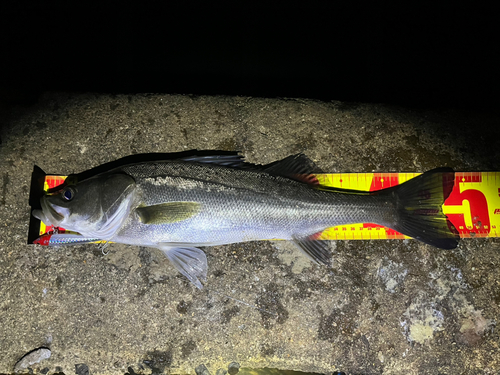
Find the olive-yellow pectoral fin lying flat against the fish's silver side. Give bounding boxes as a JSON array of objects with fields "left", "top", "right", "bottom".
[{"left": 136, "top": 202, "right": 201, "bottom": 224}]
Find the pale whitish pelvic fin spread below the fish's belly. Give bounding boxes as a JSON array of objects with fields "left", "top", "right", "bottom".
[{"left": 158, "top": 243, "right": 208, "bottom": 289}]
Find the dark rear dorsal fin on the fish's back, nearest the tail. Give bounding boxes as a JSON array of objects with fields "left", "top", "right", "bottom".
[{"left": 263, "top": 154, "right": 319, "bottom": 186}]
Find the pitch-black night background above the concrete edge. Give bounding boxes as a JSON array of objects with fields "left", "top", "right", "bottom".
[{"left": 0, "top": 1, "right": 500, "bottom": 111}]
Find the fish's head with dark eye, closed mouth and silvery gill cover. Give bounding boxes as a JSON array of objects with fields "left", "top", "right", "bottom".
[{"left": 33, "top": 173, "right": 136, "bottom": 239}]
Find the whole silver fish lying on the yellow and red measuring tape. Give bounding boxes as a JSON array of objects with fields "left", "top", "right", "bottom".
[{"left": 33, "top": 154, "right": 459, "bottom": 289}]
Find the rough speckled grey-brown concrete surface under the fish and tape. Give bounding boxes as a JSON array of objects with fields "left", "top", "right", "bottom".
[{"left": 0, "top": 93, "right": 500, "bottom": 375}]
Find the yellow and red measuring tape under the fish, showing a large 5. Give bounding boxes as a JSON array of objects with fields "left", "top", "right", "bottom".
[{"left": 39, "top": 172, "right": 500, "bottom": 240}]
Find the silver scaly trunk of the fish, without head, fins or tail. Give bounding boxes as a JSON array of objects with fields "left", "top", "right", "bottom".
[{"left": 113, "top": 162, "right": 394, "bottom": 246}]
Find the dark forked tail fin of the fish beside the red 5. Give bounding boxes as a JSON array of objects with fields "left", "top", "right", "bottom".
[{"left": 391, "top": 168, "right": 459, "bottom": 249}]
